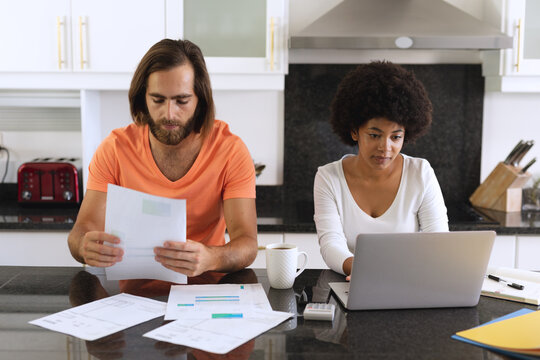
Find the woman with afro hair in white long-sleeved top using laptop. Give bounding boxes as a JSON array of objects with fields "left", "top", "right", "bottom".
[{"left": 314, "top": 62, "right": 448, "bottom": 275}]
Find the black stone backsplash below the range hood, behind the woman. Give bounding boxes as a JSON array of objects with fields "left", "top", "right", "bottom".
[{"left": 257, "top": 64, "right": 484, "bottom": 204}]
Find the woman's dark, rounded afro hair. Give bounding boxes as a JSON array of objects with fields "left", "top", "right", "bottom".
[{"left": 330, "top": 61, "right": 433, "bottom": 145}]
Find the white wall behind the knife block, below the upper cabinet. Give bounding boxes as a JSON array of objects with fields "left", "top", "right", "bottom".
[{"left": 480, "top": 92, "right": 540, "bottom": 181}]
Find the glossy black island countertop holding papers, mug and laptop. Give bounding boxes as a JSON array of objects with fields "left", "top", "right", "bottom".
[{"left": 0, "top": 266, "right": 536, "bottom": 360}]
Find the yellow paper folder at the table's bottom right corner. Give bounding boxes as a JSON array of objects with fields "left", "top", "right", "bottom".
[{"left": 456, "top": 311, "right": 540, "bottom": 356}]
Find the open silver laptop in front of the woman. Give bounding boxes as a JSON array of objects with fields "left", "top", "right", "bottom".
[{"left": 329, "top": 231, "right": 496, "bottom": 310}]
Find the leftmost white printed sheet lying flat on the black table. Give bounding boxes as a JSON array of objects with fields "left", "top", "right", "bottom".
[{"left": 29, "top": 294, "right": 166, "bottom": 341}]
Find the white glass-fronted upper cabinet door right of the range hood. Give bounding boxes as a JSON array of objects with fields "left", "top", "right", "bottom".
[{"left": 505, "top": 0, "right": 540, "bottom": 76}]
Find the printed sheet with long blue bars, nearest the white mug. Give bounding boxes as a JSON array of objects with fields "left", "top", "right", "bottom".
[{"left": 165, "top": 284, "right": 272, "bottom": 320}]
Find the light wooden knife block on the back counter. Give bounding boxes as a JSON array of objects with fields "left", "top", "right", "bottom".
[{"left": 469, "top": 162, "right": 531, "bottom": 212}]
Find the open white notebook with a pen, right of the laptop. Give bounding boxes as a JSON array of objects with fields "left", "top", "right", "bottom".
[{"left": 481, "top": 267, "right": 540, "bottom": 305}]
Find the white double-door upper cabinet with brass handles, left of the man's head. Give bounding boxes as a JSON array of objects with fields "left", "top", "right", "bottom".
[{"left": 0, "top": 0, "right": 165, "bottom": 74}]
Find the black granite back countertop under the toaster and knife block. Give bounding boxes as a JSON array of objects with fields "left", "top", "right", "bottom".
[{"left": 0, "top": 184, "right": 540, "bottom": 235}]
